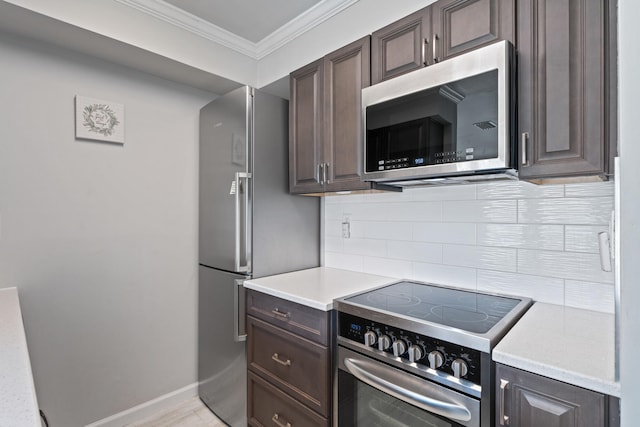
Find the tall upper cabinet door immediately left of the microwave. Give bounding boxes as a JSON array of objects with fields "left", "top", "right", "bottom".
[{"left": 324, "top": 36, "right": 371, "bottom": 191}]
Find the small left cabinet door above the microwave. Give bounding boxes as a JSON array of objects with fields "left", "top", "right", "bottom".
[{"left": 371, "top": 7, "right": 432, "bottom": 84}]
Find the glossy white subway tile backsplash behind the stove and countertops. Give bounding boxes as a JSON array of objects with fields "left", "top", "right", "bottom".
[{"left": 324, "top": 181, "right": 614, "bottom": 313}]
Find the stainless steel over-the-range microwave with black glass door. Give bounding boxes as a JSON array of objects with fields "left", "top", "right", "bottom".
[{"left": 362, "top": 41, "right": 517, "bottom": 186}]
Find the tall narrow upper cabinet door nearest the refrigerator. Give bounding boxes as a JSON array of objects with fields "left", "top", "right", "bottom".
[{"left": 289, "top": 59, "right": 324, "bottom": 193}]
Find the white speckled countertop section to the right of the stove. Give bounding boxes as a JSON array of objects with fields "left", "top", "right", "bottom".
[{"left": 493, "top": 303, "right": 620, "bottom": 397}]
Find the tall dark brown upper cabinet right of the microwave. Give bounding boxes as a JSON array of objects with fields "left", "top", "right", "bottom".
[{"left": 517, "top": 0, "right": 616, "bottom": 182}]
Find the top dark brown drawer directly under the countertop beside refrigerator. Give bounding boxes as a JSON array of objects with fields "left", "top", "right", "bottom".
[{"left": 247, "top": 289, "right": 329, "bottom": 345}]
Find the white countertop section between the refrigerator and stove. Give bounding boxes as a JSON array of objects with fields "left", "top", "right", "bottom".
[{"left": 244, "top": 267, "right": 399, "bottom": 311}]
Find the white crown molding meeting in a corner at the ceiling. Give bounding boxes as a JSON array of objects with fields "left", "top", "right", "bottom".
[{"left": 115, "top": 0, "right": 359, "bottom": 60}]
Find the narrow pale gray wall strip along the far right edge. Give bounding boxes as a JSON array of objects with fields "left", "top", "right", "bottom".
[{"left": 618, "top": 0, "right": 640, "bottom": 427}]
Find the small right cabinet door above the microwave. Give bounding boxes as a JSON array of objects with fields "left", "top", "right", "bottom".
[{"left": 431, "top": 0, "right": 515, "bottom": 62}]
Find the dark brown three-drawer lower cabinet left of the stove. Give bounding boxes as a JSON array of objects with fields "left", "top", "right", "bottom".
[{"left": 247, "top": 290, "right": 334, "bottom": 426}]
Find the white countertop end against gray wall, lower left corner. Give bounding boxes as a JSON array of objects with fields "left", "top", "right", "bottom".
[{"left": 0, "top": 288, "right": 41, "bottom": 427}]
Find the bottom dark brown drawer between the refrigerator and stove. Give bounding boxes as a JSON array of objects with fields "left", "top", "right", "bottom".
[{"left": 247, "top": 372, "right": 329, "bottom": 427}]
